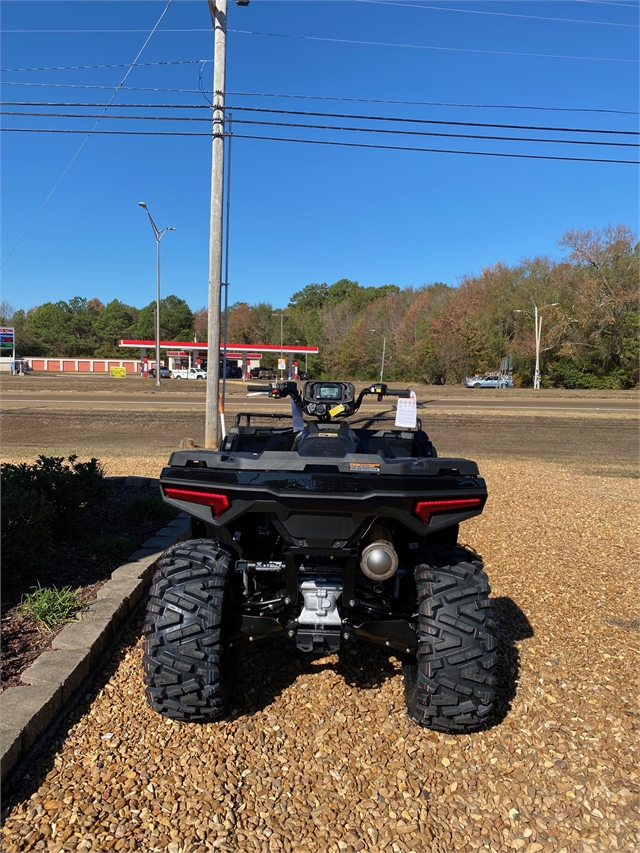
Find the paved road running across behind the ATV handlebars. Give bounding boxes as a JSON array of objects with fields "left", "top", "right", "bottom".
[{"left": 2, "top": 391, "right": 639, "bottom": 414}]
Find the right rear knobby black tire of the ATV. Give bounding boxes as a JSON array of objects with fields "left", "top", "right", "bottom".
[{"left": 403, "top": 547, "right": 497, "bottom": 733}]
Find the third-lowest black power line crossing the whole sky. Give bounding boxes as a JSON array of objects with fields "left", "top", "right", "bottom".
[{"left": 5, "top": 101, "right": 638, "bottom": 136}]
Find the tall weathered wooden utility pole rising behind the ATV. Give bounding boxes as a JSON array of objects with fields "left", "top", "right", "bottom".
[{"left": 204, "top": 0, "right": 227, "bottom": 448}]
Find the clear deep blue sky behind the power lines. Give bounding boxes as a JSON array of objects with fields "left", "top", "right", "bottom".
[{"left": 1, "top": 0, "right": 638, "bottom": 309}]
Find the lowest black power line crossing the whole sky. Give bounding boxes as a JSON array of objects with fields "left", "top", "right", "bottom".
[{"left": 0, "top": 125, "right": 638, "bottom": 166}]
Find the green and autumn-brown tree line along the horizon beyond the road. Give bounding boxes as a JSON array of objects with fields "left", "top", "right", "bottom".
[{"left": 0, "top": 225, "right": 640, "bottom": 389}]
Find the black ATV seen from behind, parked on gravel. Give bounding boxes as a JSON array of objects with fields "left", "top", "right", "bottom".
[{"left": 144, "top": 381, "right": 497, "bottom": 733}]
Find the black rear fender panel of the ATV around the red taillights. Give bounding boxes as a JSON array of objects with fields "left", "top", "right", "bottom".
[{"left": 160, "top": 451, "right": 487, "bottom": 553}]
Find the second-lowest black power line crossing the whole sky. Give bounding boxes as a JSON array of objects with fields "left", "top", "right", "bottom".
[{"left": 0, "top": 110, "right": 638, "bottom": 148}]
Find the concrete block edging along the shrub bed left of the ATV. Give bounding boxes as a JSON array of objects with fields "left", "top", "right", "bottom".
[{"left": 0, "top": 513, "right": 190, "bottom": 781}]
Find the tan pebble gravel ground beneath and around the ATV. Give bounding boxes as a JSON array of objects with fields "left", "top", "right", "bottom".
[{"left": 2, "top": 458, "right": 640, "bottom": 853}]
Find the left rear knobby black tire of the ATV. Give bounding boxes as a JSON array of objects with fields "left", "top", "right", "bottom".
[{"left": 143, "top": 539, "right": 231, "bottom": 721}]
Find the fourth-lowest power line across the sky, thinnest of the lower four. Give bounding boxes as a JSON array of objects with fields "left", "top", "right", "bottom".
[{"left": 2, "top": 80, "right": 640, "bottom": 115}]
